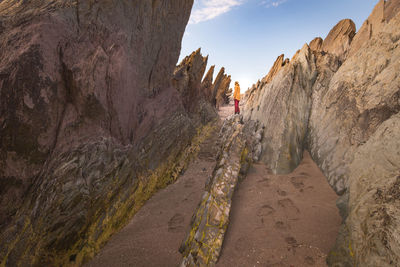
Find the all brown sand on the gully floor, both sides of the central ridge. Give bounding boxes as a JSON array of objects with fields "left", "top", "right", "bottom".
[{"left": 87, "top": 105, "right": 341, "bottom": 267}]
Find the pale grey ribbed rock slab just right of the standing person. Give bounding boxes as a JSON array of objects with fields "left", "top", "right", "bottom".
[{"left": 243, "top": 45, "right": 317, "bottom": 173}]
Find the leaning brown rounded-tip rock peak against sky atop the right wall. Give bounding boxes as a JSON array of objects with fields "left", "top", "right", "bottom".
[{"left": 322, "top": 19, "right": 356, "bottom": 60}]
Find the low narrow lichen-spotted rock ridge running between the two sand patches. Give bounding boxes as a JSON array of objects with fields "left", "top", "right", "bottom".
[{"left": 179, "top": 115, "right": 263, "bottom": 266}]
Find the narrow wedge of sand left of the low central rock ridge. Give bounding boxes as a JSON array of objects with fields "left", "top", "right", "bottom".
[{"left": 87, "top": 127, "right": 219, "bottom": 267}]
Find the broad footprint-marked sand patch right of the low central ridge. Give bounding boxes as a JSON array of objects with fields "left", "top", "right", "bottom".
[{"left": 217, "top": 152, "right": 341, "bottom": 267}]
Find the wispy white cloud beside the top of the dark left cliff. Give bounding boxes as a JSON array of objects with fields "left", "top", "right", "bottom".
[{"left": 189, "top": 0, "right": 244, "bottom": 24}]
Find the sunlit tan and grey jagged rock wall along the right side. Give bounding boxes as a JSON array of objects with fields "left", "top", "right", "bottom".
[{"left": 244, "top": 0, "right": 400, "bottom": 266}]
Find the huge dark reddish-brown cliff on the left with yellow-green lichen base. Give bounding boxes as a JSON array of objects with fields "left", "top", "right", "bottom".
[{"left": 0, "top": 0, "right": 219, "bottom": 266}]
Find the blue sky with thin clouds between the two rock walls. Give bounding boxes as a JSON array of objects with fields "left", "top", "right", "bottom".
[{"left": 179, "top": 0, "right": 378, "bottom": 92}]
